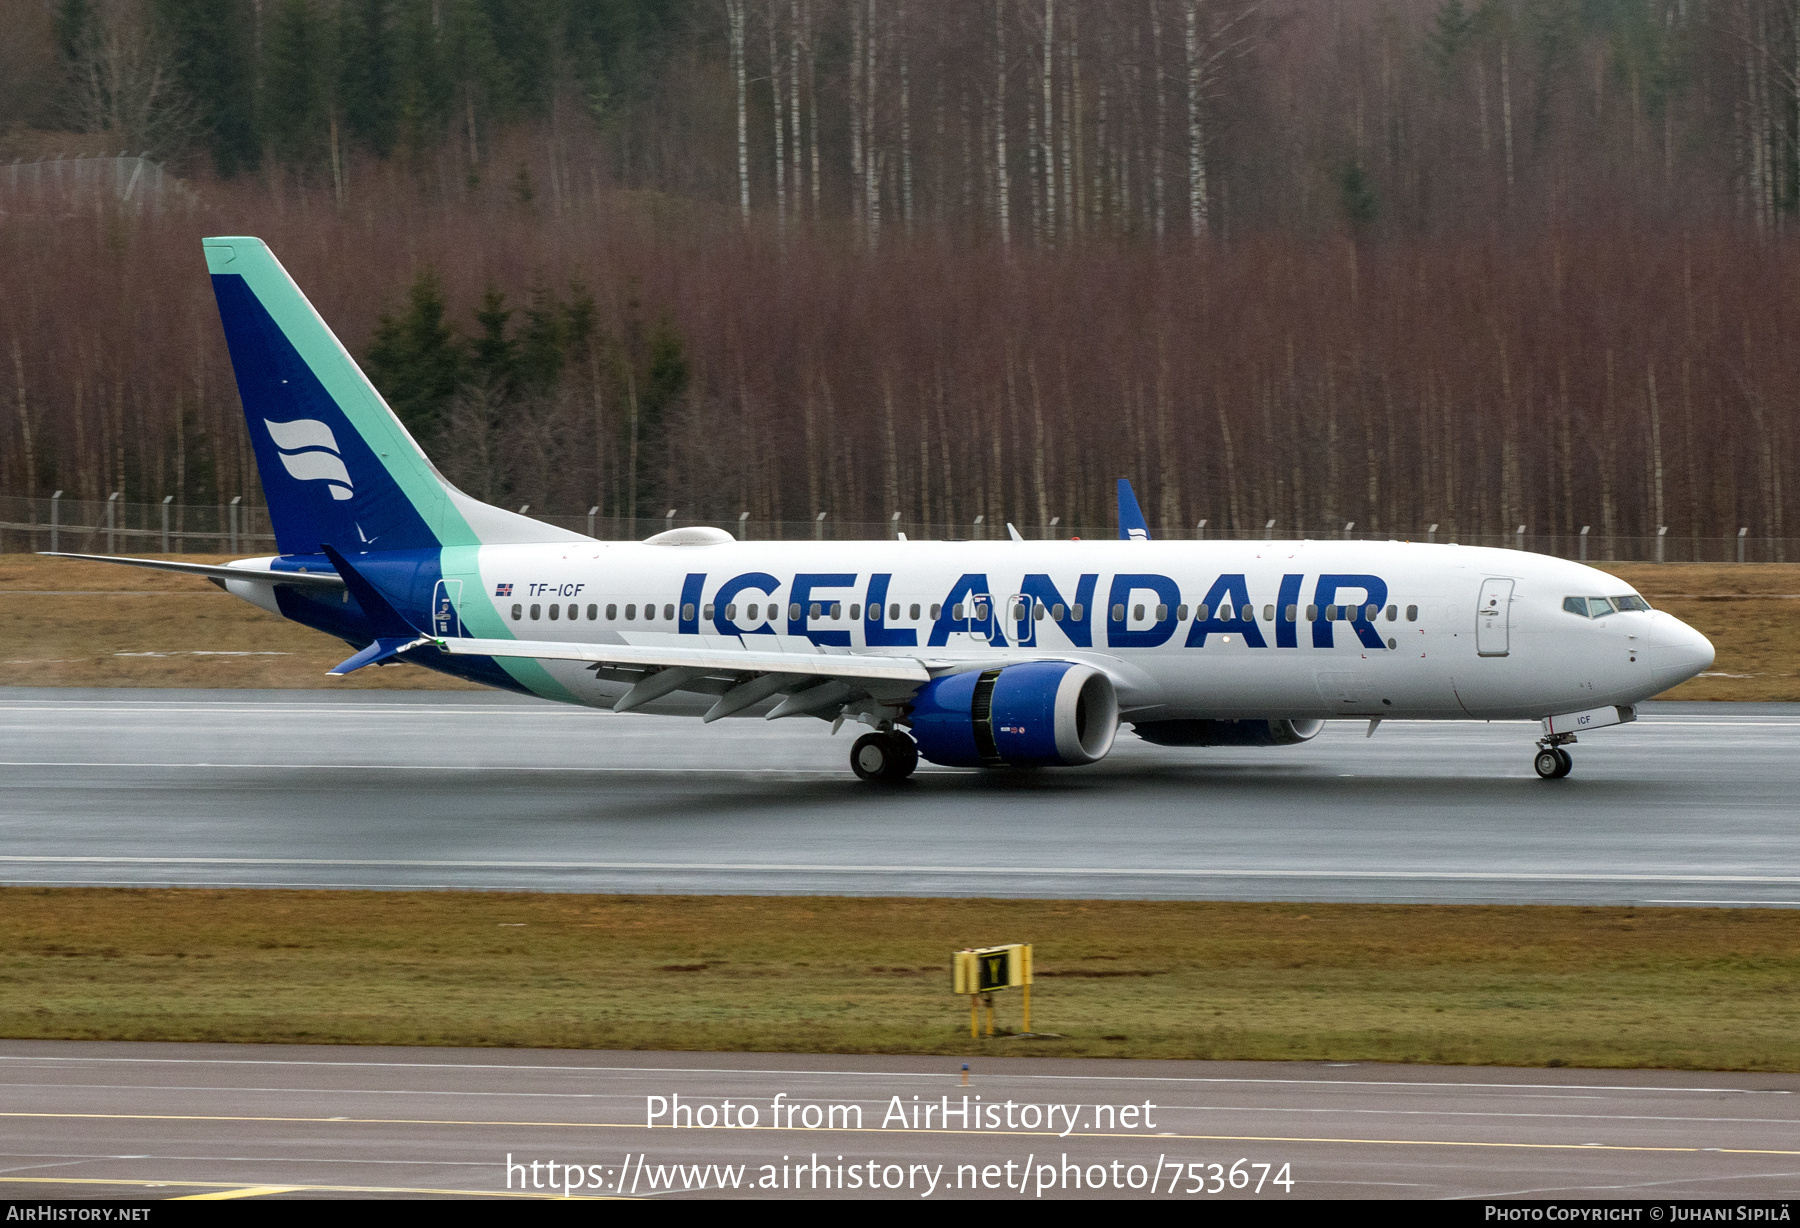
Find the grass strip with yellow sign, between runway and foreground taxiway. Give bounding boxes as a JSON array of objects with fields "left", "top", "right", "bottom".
[{"left": 0, "top": 888, "right": 1800, "bottom": 1071}]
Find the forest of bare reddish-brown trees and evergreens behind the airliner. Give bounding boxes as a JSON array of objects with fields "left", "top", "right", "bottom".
[{"left": 0, "top": 0, "right": 1800, "bottom": 543}]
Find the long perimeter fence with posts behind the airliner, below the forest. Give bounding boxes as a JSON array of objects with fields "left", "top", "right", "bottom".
[{"left": 0, "top": 495, "right": 1800, "bottom": 564}]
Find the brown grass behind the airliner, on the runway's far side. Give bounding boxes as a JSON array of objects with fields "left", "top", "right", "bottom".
[{"left": 0, "top": 555, "right": 1800, "bottom": 700}]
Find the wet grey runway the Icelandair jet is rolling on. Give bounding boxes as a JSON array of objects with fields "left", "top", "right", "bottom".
[{"left": 0, "top": 688, "right": 1800, "bottom": 906}]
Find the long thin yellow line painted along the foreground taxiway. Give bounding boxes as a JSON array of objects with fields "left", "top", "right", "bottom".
[{"left": 0, "top": 1113, "right": 1800, "bottom": 1152}]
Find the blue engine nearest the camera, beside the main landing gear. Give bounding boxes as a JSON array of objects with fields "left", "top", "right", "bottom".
[{"left": 913, "top": 661, "right": 1120, "bottom": 767}]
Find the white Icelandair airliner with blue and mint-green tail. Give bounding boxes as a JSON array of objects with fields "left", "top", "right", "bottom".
[{"left": 52, "top": 238, "right": 1714, "bottom": 781}]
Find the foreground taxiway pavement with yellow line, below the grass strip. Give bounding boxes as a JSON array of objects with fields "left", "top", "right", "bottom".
[{"left": 0, "top": 1041, "right": 1800, "bottom": 1199}]
